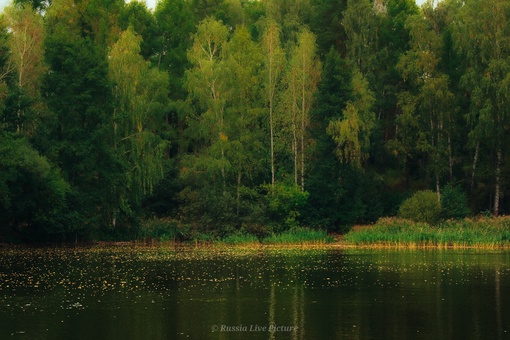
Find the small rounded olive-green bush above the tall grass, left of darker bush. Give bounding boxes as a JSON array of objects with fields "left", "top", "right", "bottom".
[{"left": 398, "top": 190, "right": 441, "bottom": 224}]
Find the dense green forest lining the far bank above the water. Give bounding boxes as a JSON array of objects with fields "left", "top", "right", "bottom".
[{"left": 0, "top": 0, "right": 510, "bottom": 242}]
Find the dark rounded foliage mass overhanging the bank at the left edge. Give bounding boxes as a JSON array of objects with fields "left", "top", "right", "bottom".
[{"left": 0, "top": 133, "right": 69, "bottom": 241}]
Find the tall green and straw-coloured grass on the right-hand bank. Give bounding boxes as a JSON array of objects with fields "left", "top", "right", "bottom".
[{"left": 344, "top": 217, "right": 510, "bottom": 248}]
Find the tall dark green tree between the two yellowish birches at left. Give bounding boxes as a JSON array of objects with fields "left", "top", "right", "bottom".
[{"left": 41, "top": 0, "right": 120, "bottom": 237}]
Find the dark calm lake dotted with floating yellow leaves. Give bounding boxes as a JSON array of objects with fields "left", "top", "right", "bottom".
[{"left": 0, "top": 247, "right": 510, "bottom": 339}]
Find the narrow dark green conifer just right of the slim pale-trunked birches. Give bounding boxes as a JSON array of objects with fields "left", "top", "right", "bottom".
[{"left": 305, "top": 48, "right": 359, "bottom": 228}]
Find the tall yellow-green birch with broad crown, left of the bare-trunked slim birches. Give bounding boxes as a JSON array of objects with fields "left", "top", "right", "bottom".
[{"left": 180, "top": 18, "right": 231, "bottom": 227}]
